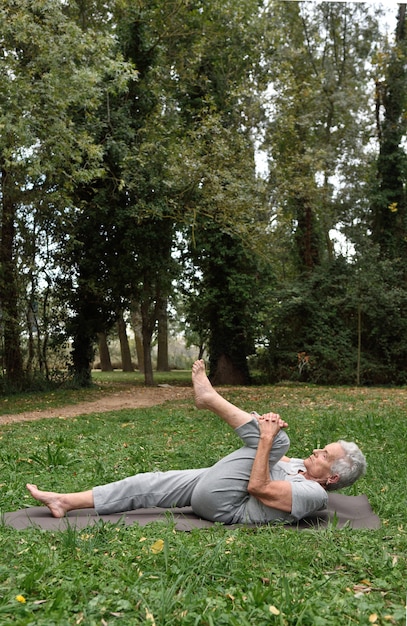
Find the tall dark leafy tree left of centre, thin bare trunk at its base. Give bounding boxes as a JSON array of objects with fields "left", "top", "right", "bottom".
[{"left": 64, "top": 1, "right": 188, "bottom": 384}]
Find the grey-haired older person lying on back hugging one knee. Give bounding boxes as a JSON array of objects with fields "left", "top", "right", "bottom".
[{"left": 27, "top": 360, "right": 366, "bottom": 524}]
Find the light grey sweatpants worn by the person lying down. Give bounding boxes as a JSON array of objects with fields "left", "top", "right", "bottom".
[{"left": 93, "top": 419, "right": 290, "bottom": 524}]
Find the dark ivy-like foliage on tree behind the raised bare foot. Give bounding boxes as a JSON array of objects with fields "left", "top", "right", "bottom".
[{"left": 186, "top": 223, "right": 272, "bottom": 384}]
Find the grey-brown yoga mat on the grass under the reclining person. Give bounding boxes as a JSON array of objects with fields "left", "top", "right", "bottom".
[{"left": 0, "top": 493, "right": 380, "bottom": 531}]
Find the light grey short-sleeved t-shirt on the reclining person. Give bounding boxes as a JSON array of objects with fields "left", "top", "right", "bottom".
[{"left": 244, "top": 459, "right": 328, "bottom": 523}]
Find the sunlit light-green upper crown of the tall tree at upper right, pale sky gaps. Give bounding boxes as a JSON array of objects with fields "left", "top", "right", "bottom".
[{"left": 264, "top": 2, "right": 378, "bottom": 272}]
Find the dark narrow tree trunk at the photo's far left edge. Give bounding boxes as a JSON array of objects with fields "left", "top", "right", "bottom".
[{"left": 0, "top": 163, "right": 24, "bottom": 387}]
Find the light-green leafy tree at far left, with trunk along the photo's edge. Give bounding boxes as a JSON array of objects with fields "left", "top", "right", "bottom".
[{"left": 0, "top": 0, "right": 127, "bottom": 384}]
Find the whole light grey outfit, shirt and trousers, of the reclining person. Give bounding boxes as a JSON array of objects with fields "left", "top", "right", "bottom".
[{"left": 93, "top": 419, "right": 327, "bottom": 524}]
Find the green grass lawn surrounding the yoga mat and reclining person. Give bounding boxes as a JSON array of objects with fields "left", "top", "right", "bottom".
[{"left": 0, "top": 385, "right": 407, "bottom": 626}]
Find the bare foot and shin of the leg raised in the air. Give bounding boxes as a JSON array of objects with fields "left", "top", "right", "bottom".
[{"left": 192, "top": 359, "right": 253, "bottom": 428}]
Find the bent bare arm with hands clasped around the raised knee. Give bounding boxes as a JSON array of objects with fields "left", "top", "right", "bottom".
[{"left": 247, "top": 414, "right": 292, "bottom": 513}]
